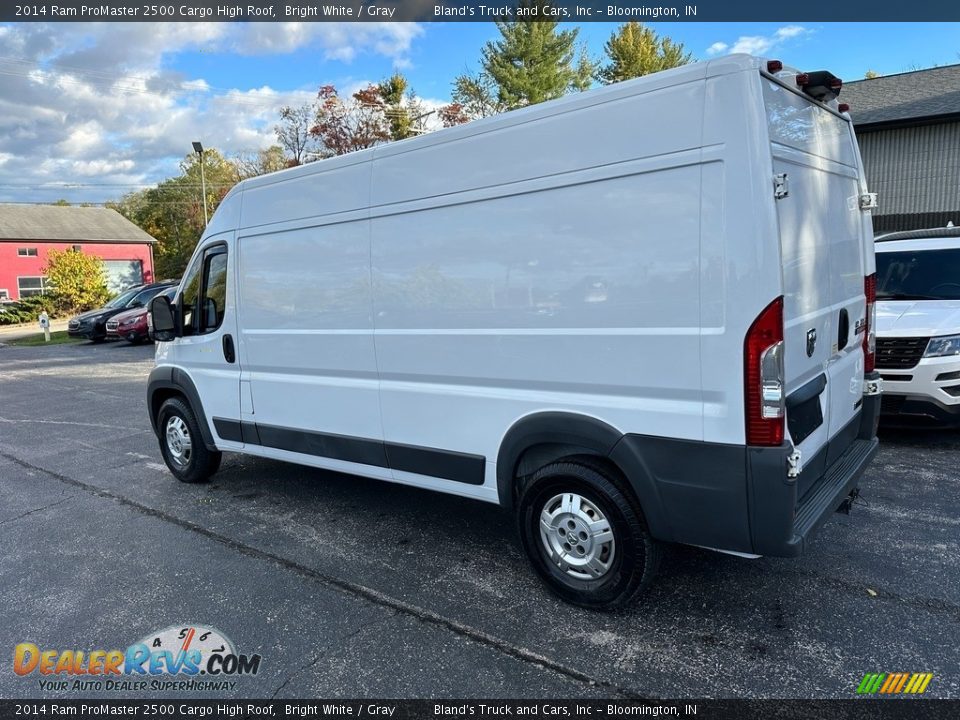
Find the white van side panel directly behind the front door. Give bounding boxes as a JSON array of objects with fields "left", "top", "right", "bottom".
[{"left": 239, "top": 218, "right": 383, "bottom": 456}]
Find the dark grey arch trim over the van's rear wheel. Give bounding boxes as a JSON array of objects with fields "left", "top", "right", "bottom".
[{"left": 497, "top": 412, "right": 672, "bottom": 540}]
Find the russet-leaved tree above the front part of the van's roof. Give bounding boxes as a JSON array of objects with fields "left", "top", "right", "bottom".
[{"left": 310, "top": 85, "right": 392, "bottom": 157}]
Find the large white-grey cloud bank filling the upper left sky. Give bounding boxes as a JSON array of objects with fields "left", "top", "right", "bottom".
[{"left": 0, "top": 23, "right": 424, "bottom": 202}]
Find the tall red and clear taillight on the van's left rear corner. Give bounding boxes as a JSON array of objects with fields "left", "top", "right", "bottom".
[{"left": 743, "top": 297, "right": 785, "bottom": 446}]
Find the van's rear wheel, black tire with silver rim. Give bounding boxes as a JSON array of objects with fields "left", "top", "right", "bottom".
[{"left": 517, "top": 458, "right": 662, "bottom": 610}]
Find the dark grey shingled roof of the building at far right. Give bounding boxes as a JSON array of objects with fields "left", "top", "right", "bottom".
[{"left": 840, "top": 65, "right": 960, "bottom": 126}]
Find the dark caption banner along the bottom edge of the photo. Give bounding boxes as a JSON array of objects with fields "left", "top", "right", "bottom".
[{"left": 0, "top": 698, "right": 960, "bottom": 720}]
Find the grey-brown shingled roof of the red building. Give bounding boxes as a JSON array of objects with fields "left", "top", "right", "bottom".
[{"left": 0, "top": 204, "right": 156, "bottom": 243}]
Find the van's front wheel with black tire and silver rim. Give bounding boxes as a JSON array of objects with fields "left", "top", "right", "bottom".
[{"left": 157, "top": 397, "right": 222, "bottom": 483}]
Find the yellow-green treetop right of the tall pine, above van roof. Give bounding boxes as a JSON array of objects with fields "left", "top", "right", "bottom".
[{"left": 597, "top": 21, "right": 693, "bottom": 85}]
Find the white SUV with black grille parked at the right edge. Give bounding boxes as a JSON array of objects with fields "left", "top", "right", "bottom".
[{"left": 876, "top": 227, "right": 960, "bottom": 427}]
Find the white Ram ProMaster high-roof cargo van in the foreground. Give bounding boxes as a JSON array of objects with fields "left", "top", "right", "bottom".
[{"left": 148, "top": 55, "right": 879, "bottom": 607}]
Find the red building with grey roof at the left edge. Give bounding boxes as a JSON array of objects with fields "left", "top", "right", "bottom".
[{"left": 0, "top": 204, "right": 156, "bottom": 300}]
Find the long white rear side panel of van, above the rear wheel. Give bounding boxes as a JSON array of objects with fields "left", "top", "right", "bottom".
[{"left": 371, "top": 83, "right": 702, "bottom": 492}]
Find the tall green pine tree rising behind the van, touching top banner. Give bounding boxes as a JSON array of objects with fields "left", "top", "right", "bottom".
[{"left": 482, "top": 0, "right": 593, "bottom": 110}]
